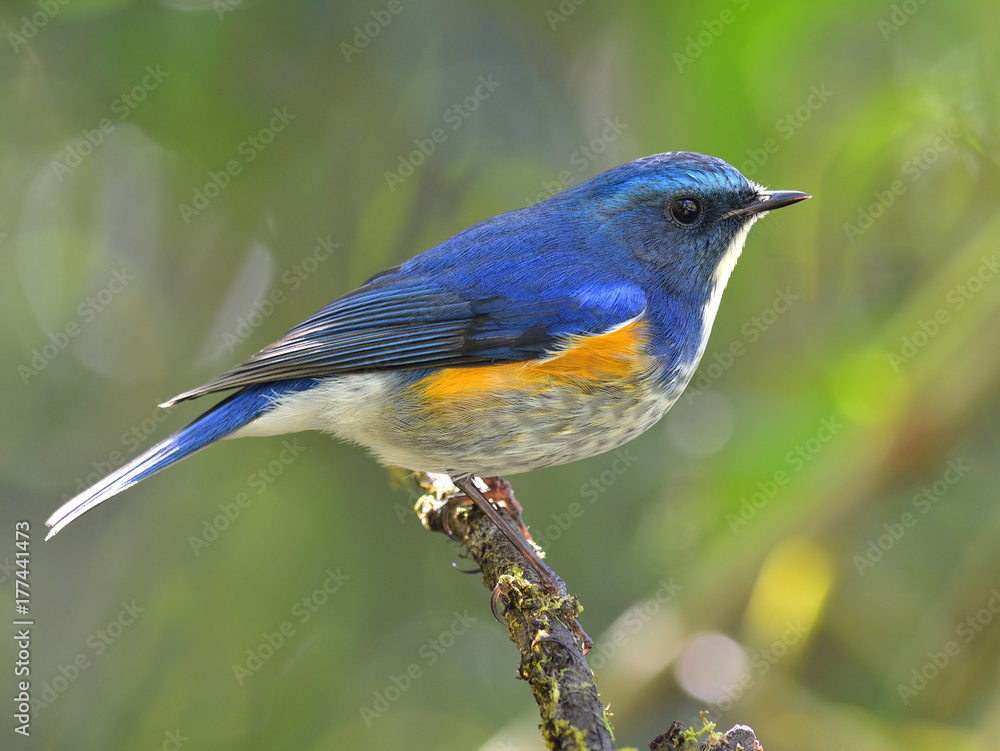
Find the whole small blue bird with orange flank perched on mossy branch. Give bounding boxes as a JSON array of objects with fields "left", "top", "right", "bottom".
[{"left": 46, "top": 152, "right": 809, "bottom": 576}]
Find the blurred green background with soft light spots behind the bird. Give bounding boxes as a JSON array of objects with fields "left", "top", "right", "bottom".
[{"left": 0, "top": 0, "right": 1000, "bottom": 751}]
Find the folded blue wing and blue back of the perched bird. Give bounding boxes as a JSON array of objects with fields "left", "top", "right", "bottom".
[{"left": 165, "top": 209, "right": 646, "bottom": 405}]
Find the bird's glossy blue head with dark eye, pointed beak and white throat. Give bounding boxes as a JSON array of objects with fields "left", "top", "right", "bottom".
[{"left": 575, "top": 151, "right": 810, "bottom": 305}]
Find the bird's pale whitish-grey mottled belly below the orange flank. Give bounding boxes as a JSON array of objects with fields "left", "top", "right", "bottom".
[{"left": 232, "top": 373, "right": 677, "bottom": 476}]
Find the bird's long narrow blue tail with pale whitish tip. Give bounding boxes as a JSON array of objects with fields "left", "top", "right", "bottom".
[{"left": 45, "top": 378, "right": 316, "bottom": 540}]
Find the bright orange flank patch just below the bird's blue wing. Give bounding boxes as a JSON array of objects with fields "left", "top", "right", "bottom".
[{"left": 417, "top": 321, "right": 648, "bottom": 402}]
